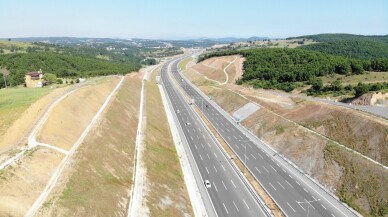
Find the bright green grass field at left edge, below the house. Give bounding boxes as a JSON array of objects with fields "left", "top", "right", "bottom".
[{"left": 0, "top": 88, "right": 53, "bottom": 135}]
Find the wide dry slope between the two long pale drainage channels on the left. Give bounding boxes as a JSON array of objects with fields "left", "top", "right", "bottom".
[{"left": 37, "top": 74, "right": 141, "bottom": 216}]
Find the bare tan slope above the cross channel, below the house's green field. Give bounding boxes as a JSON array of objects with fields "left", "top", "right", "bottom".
[{"left": 37, "top": 77, "right": 119, "bottom": 150}]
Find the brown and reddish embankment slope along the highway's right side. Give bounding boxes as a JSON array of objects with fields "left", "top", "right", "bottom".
[{"left": 185, "top": 56, "right": 388, "bottom": 216}]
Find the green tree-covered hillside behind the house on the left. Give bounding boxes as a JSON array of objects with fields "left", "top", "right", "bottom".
[{"left": 0, "top": 52, "right": 140, "bottom": 86}]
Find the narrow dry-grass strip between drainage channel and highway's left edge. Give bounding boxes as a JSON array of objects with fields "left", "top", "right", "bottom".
[{"left": 143, "top": 67, "right": 193, "bottom": 216}]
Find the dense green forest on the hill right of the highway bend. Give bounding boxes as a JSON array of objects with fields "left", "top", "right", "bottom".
[{"left": 199, "top": 48, "right": 388, "bottom": 94}]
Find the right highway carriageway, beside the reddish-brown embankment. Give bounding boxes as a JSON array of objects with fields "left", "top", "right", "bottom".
[{"left": 172, "top": 56, "right": 356, "bottom": 217}]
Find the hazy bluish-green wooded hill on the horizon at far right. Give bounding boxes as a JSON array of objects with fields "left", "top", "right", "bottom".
[{"left": 289, "top": 34, "right": 388, "bottom": 60}]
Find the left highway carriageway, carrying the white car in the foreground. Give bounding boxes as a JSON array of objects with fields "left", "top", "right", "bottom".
[{"left": 160, "top": 59, "right": 267, "bottom": 217}]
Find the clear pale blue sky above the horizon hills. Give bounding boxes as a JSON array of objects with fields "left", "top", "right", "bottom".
[{"left": 0, "top": 0, "right": 388, "bottom": 39}]
